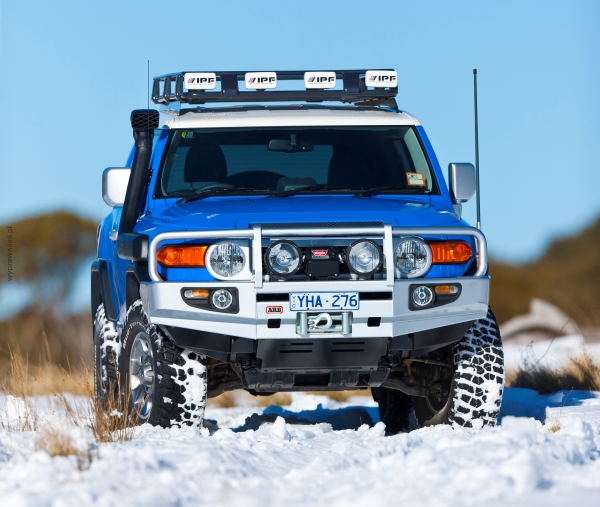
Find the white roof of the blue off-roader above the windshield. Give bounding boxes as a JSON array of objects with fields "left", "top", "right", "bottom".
[{"left": 161, "top": 109, "right": 420, "bottom": 129}]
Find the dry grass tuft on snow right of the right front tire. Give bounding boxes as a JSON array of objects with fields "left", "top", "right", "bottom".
[{"left": 506, "top": 349, "right": 600, "bottom": 394}]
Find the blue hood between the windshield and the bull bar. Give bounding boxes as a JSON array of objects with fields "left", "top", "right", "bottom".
[{"left": 136, "top": 195, "right": 460, "bottom": 234}]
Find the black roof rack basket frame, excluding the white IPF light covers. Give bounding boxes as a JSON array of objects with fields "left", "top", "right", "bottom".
[{"left": 152, "top": 69, "right": 398, "bottom": 111}]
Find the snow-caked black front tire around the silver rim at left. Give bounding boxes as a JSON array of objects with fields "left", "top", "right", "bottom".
[{"left": 99, "top": 300, "right": 207, "bottom": 428}]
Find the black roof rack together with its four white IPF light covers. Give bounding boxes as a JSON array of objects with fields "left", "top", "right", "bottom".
[{"left": 152, "top": 69, "right": 398, "bottom": 111}]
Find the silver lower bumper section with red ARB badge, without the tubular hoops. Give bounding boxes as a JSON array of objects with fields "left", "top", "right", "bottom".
[{"left": 140, "top": 276, "right": 490, "bottom": 340}]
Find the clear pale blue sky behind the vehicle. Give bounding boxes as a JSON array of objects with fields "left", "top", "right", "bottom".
[{"left": 0, "top": 0, "right": 600, "bottom": 261}]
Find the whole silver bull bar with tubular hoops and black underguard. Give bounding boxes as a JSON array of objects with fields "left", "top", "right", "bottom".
[{"left": 140, "top": 224, "right": 489, "bottom": 378}]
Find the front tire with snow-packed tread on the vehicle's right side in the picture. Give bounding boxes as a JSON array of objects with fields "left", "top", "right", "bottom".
[{"left": 413, "top": 308, "right": 504, "bottom": 428}]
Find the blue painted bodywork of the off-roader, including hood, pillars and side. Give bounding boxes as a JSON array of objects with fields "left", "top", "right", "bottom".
[{"left": 98, "top": 122, "right": 475, "bottom": 323}]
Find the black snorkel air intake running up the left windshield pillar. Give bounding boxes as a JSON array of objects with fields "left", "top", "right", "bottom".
[{"left": 117, "top": 109, "right": 158, "bottom": 261}]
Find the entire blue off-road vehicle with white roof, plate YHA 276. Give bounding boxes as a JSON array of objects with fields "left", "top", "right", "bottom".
[{"left": 92, "top": 70, "right": 504, "bottom": 433}]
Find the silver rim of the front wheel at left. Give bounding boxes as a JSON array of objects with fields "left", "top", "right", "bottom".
[{"left": 129, "top": 333, "right": 154, "bottom": 421}]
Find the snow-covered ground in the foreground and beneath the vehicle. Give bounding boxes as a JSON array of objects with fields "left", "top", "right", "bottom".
[{"left": 0, "top": 389, "right": 600, "bottom": 507}]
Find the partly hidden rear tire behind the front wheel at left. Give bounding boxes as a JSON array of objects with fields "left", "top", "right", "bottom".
[{"left": 94, "top": 304, "right": 121, "bottom": 399}]
